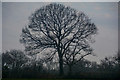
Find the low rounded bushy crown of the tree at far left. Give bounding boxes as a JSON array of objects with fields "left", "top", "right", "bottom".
[{"left": 2, "top": 50, "right": 28, "bottom": 69}]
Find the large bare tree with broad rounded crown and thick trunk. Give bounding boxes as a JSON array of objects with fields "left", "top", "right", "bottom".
[{"left": 20, "top": 3, "right": 97, "bottom": 75}]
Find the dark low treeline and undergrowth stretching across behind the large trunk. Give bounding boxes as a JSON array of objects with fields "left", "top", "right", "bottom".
[{"left": 2, "top": 50, "right": 120, "bottom": 79}]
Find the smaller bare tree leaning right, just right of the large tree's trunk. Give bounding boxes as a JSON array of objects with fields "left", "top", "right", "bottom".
[{"left": 63, "top": 41, "right": 93, "bottom": 75}]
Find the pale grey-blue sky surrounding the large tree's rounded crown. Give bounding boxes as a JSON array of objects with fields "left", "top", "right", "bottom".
[{"left": 2, "top": 2, "right": 118, "bottom": 61}]
